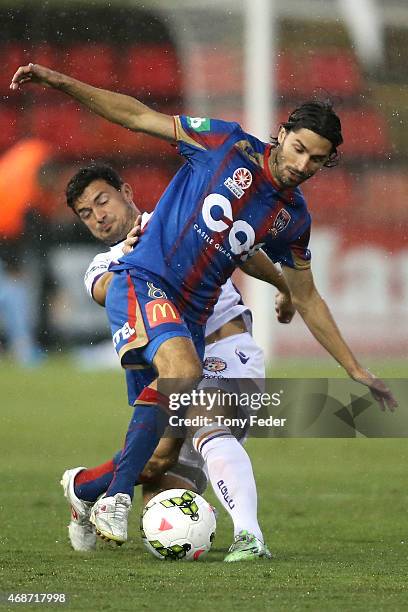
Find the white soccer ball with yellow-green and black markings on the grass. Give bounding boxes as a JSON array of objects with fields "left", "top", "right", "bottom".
[{"left": 140, "top": 489, "right": 216, "bottom": 561}]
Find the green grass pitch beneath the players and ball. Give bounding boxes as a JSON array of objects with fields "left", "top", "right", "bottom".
[{"left": 0, "top": 358, "right": 408, "bottom": 612}]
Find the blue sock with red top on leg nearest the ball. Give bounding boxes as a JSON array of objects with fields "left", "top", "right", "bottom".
[{"left": 106, "top": 387, "right": 168, "bottom": 498}]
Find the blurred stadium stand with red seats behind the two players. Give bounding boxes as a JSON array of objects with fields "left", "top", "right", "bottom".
[{"left": 0, "top": 0, "right": 408, "bottom": 364}]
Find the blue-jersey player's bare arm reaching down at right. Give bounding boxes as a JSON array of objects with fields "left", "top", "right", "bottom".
[{"left": 283, "top": 266, "right": 398, "bottom": 410}]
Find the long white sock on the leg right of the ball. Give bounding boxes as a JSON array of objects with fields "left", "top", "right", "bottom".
[{"left": 193, "top": 424, "right": 264, "bottom": 542}]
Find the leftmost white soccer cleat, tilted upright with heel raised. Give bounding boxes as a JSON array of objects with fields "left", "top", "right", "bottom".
[{"left": 61, "top": 467, "right": 96, "bottom": 552}]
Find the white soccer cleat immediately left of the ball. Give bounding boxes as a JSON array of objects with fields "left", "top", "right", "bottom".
[{"left": 90, "top": 493, "right": 132, "bottom": 545}]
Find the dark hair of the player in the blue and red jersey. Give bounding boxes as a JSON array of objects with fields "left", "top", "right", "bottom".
[{"left": 272, "top": 100, "right": 343, "bottom": 167}]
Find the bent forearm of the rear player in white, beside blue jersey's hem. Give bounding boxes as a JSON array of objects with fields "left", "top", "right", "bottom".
[{"left": 241, "top": 251, "right": 296, "bottom": 323}]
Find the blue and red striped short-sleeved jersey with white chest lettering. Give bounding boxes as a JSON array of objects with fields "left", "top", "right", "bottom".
[{"left": 110, "top": 116, "right": 311, "bottom": 323}]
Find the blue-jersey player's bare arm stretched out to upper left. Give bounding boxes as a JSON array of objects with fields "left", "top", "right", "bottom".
[{"left": 10, "top": 63, "right": 174, "bottom": 140}]
